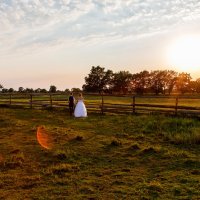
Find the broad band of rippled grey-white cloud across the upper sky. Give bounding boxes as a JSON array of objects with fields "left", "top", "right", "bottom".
[{"left": 0, "top": 0, "right": 200, "bottom": 54}]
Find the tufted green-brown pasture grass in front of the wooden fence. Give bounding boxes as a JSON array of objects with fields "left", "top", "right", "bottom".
[{"left": 0, "top": 108, "right": 200, "bottom": 200}]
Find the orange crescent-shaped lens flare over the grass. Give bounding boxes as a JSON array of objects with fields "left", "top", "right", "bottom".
[{"left": 37, "top": 126, "right": 53, "bottom": 149}]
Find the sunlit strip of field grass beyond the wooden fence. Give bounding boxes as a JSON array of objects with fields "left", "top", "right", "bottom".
[{"left": 0, "top": 94, "right": 200, "bottom": 107}]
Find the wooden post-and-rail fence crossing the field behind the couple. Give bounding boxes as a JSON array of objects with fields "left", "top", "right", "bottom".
[{"left": 0, "top": 93, "right": 200, "bottom": 116}]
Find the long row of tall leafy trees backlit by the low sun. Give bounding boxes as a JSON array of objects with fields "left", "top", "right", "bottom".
[{"left": 83, "top": 66, "right": 200, "bottom": 95}]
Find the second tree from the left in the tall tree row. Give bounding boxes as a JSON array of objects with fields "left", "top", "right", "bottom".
[{"left": 113, "top": 71, "right": 132, "bottom": 94}]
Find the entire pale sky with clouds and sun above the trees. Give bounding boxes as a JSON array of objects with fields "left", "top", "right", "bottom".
[{"left": 0, "top": 0, "right": 200, "bottom": 90}]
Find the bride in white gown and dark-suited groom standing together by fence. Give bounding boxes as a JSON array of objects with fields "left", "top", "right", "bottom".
[{"left": 69, "top": 93, "right": 87, "bottom": 117}]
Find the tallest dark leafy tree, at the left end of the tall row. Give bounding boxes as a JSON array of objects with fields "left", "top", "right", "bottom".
[{"left": 82, "top": 66, "right": 113, "bottom": 92}]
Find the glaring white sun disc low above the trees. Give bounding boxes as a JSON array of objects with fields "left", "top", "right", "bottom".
[{"left": 167, "top": 36, "right": 200, "bottom": 72}]
